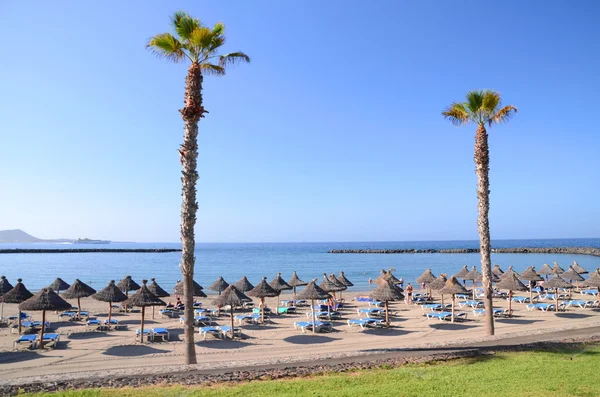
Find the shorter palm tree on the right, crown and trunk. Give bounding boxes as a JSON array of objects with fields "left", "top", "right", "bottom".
[{"left": 442, "top": 90, "right": 517, "bottom": 335}]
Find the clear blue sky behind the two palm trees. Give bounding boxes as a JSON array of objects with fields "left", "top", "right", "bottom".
[{"left": 0, "top": 0, "right": 600, "bottom": 242}]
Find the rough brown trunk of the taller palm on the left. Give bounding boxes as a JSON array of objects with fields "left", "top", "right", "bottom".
[{"left": 179, "top": 62, "right": 205, "bottom": 364}]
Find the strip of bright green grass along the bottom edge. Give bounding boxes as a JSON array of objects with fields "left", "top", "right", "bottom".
[{"left": 18, "top": 346, "right": 600, "bottom": 397}]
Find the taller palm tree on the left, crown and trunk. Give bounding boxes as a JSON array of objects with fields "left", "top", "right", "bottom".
[{"left": 146, "top": 11, "right": 250, "bottom": 364}]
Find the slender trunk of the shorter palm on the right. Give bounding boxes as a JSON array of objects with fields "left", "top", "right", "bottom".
[{"left": 474, "top": 125, "right": 494, "bottom": 336}]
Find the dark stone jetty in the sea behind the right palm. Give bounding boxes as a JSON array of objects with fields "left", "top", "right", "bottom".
[{"left": 328, "top": 247, "right": 600, "bottom": 256}]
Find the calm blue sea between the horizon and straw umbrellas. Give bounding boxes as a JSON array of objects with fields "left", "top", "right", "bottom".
[{"left": 0, "top": 239, "right": 600, "bottom": 292}]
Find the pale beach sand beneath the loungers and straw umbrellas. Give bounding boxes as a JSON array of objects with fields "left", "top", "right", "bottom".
[{"left": 0, "top": 292, "right": 600, "bottom": 384}]
